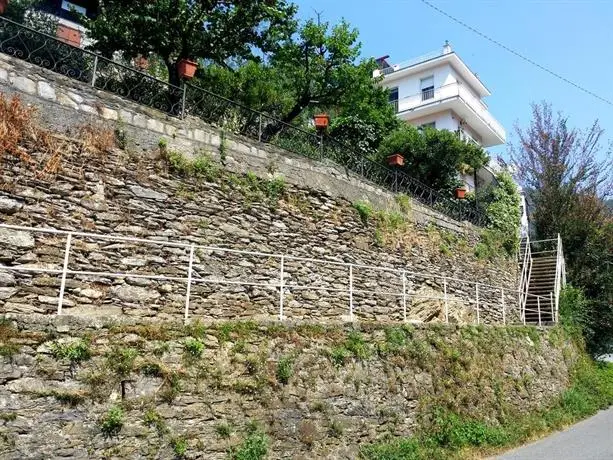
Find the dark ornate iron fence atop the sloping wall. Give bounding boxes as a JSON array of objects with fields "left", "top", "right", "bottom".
[{"left": 0, "top": 17, "right": 487, "bottom": 226}]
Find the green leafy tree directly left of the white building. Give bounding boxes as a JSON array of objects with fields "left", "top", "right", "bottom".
[{"left": 266, "top": 20, "right": 397, "bottom": 140}]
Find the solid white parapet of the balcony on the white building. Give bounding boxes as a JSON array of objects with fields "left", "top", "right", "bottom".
[{"left": 397, "top": 82, "right": 506, "bottom": 137}]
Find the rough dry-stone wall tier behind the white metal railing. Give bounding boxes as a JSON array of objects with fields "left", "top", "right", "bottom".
[{"left": 0, "top": 139, "right": 518, "bottom": 324}]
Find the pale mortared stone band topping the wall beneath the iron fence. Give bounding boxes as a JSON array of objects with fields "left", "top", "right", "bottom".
[{"left": 0, "top": 53, "right": 476, "bottom": 233}]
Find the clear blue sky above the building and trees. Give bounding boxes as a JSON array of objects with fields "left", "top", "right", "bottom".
[{"left": 295, "top": 0, "right": 613, "bottom": 162}]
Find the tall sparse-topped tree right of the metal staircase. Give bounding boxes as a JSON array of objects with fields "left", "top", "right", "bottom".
[{"left": 512, "top": 103, "right": 613, "bottom": 354}]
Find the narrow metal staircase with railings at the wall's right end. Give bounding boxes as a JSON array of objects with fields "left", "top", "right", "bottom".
[{"left": 519, "top": 235, "right": 566, "bottom": 326}]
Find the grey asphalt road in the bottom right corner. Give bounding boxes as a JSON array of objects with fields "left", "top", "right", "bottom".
[{"left": 496, "top": 408, "right": 613, "bottom": 460}]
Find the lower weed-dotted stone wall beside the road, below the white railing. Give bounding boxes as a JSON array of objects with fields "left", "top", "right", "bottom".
[{"left": 0, "top": 314, "right": 578, "bottom": 460}]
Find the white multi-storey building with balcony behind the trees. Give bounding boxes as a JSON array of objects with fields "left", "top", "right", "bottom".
[{"left": 374, "top": 42, "right": 506, "bottom": 190}]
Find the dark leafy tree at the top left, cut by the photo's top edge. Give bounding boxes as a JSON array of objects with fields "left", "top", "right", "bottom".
[{"left": 87, "top": 0, "right": 296, "bottom": 85}]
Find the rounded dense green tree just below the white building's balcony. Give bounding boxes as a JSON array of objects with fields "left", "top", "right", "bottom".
[{"left": 378, "top": 125, "right": 489, "bottom": 191}]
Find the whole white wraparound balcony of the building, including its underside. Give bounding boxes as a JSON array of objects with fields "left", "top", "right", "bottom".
[{"left": 391, "top": 83, "right": 506, "bottom": 147}]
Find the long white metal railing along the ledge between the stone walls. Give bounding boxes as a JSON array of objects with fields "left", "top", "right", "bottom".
[{"left": 0, "top": 224, "right": 549, "bottom": 324}]
